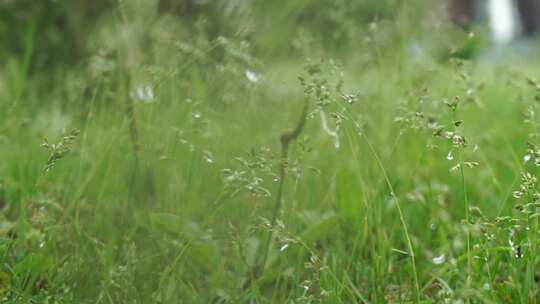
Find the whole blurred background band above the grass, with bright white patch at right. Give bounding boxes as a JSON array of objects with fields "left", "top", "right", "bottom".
[{"left": 0, "top": 0, "right": 540, "bottom": 103}]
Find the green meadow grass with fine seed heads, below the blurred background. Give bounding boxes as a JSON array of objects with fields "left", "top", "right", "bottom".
[{"left": 0, "top": 1, "right": 540, "bottom": 303}]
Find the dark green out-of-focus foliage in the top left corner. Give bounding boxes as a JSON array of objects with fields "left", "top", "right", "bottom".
[{"left": 0, "top": 0, "right": 112, "bottom": 69}]
